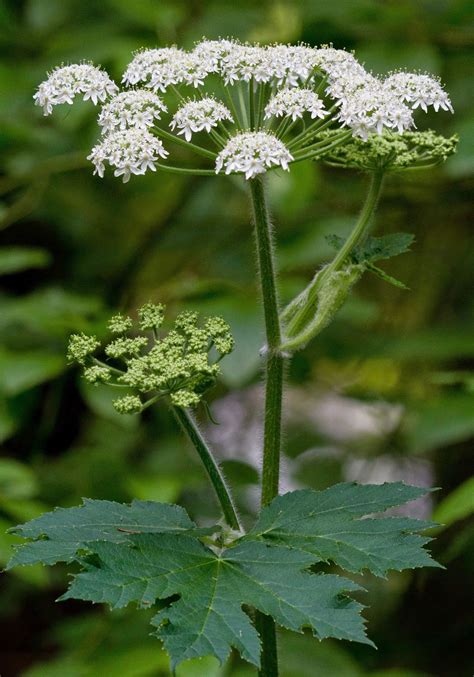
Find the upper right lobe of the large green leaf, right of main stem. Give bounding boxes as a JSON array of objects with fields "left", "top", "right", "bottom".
[{"left": 248, "top": 482, "right": 439, "bottom": 576}]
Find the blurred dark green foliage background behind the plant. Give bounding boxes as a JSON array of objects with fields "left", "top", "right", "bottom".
[{"left": 0, "top": 0, "right": 474, "bottom": 677}]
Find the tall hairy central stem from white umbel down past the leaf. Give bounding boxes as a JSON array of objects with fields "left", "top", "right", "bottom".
[{"left": 249, "top": 177, "right": 284, "bottom": 677}]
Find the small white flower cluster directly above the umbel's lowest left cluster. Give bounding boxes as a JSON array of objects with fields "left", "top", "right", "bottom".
[{"left": 98, "top": 89, "right": 167, "bottom": 134}]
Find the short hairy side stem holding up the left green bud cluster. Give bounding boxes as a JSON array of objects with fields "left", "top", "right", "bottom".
[{"left": 171, "top": 407, "right": 241, "bottom": 531}]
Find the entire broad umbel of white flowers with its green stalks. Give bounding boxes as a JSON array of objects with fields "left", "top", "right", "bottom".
[{"left": 34, "top": 40, "right": 452, "bottom": 182}]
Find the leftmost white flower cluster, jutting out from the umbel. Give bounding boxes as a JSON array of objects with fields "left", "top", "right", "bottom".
[{"left": 33, "top": 63, "right": 118, "bottom": 115}]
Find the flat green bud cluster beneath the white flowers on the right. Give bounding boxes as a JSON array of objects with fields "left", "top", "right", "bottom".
[{"left": 318, "top": 130, "right": 458, "bottom": 172}]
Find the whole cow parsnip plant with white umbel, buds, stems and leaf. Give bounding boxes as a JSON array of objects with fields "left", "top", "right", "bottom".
[{"left": 9, "top": 40, "right": 456, "bottom": 677}]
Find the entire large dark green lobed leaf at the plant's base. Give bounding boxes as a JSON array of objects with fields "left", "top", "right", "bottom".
[{"left": 5, "top": 483, "right": 436, "bottom": 666}]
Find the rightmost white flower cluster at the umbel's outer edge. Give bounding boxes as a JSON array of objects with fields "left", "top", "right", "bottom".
[{"left": 383, "top": 72, "right": 454, "bottom": 113}]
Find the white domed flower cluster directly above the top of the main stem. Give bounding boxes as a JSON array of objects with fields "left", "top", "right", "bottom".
[{"left": 216, "top": 132, "right": 293, "bottom": 179}]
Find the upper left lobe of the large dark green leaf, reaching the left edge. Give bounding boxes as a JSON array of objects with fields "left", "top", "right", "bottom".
[{"left": 7, "top": 499, "right": 215, "bottom": 569}]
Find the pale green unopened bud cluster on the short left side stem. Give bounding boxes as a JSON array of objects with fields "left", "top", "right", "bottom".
[{"left": 68, "top": 303, "right": 234, "bottom": 414}]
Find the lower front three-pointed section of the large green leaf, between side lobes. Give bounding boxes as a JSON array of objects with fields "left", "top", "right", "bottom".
[{"left": 61, "top": 534, "right": 370, "bottom": 667}]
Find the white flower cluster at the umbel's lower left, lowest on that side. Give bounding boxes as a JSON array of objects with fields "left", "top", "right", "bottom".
[{"left": 87, "top": 128, "right": 168, "bottom": 183}]
